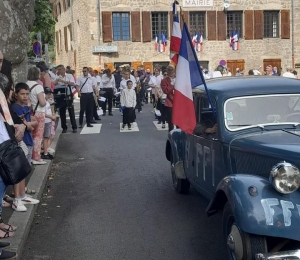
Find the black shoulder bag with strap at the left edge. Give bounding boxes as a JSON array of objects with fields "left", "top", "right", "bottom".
[{"left": 0, "top": 105, "right": 31, "bottom": 185}]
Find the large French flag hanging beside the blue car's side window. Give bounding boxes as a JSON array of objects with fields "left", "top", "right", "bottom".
[{"left": 172, "top": 23, "right": 205, "bottom": 134}]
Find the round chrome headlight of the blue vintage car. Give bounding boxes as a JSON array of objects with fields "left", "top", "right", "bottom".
[{"left": 270, "top": 162, "right": 300, "bottom": 194}]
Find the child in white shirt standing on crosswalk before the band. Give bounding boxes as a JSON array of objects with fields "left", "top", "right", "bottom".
[{"left": 121, "top": 80, "right": 136, "bottom": 130}]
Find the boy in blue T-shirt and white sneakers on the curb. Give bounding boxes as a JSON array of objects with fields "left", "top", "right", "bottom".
[{"left": 12, "top": 83, "right": 39, "bottom": 211}]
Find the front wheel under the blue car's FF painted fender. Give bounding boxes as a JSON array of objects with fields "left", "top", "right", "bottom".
[{"left": 222, "top": 202, "right": 267, "bottom": 260}]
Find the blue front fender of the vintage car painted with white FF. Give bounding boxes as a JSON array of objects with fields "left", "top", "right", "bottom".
[{"left": 206, "top": 174, "right": 300, "bottom": 241}]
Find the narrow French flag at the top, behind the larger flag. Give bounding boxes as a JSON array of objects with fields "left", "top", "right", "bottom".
[{"left": 170, "top": 1, "right": 181, "bottom": 65}]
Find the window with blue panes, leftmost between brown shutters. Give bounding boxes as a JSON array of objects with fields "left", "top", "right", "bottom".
[{"left": 112, "top": 13, "right": 130, "bottom": 41}]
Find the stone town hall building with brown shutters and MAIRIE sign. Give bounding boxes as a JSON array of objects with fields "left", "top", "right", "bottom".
[{"left": 50, "top": 0, "right": 300, "bottom": 73}]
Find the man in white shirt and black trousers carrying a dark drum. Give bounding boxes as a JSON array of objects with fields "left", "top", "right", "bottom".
[{"left": 54, "top": 65, "right": 77, "bottom": 133}]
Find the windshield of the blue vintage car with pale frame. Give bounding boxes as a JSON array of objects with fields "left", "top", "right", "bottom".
[{"left": 224, "top": 94, "right": 300, "bottom": 131}]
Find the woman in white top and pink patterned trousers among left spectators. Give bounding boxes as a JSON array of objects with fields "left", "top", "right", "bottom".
[{"left": 26, "top": 67, "right": 47, "bottom": 165}]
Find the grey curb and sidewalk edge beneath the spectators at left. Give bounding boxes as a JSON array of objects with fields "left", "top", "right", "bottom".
[{"left": 4, "top": 121, "right": 61, "bottom": 260}]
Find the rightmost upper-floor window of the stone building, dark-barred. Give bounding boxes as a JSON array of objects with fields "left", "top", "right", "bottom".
[{"left": 264, "top": 11, "right": 279, "bottom": 38}]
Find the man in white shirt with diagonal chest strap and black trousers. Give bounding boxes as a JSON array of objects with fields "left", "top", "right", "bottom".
[{"left": 76, "top": 67, "right": 97, "bottom": 128}]
